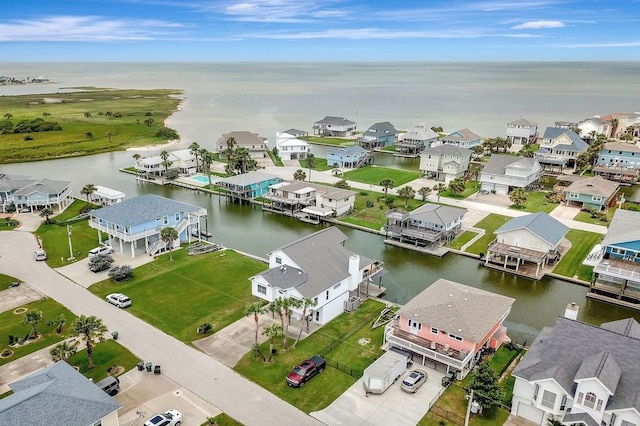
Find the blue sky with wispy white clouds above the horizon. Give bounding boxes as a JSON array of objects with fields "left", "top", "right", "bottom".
[{"left": 0, "top": 0, "right": 640, "bottom": 62}]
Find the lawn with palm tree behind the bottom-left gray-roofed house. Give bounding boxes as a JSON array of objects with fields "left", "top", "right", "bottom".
[{"left": 67, "top": 339, "right": 140, "bottom": 382}]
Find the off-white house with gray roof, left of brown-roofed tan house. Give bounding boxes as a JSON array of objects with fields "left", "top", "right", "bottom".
[{"left": 480, "top": 154, "right": 542, "bottom": 195}]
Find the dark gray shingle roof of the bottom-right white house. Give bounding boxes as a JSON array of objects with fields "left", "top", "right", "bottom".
[{"left": 512, "top": 317, "right": 640, "bottom": 410}]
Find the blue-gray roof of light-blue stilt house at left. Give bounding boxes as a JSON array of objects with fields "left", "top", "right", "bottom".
[{"left": 90, "top": 194, "right": 203, "bottom": 226}]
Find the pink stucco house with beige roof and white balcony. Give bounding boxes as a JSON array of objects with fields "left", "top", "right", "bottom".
[{"left": 384, "top": 278, "right": 515, "bottom": 379}]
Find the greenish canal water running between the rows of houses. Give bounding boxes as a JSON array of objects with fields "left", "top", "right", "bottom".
[{"left": 0, "top": 152, "right": 640, "bottom": 342}]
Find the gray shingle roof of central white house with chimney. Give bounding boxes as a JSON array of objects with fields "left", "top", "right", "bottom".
[{"left": 272, "top": 226, "right": 373, "bottom": 297}]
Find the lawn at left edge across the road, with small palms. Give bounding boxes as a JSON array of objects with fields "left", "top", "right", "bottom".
[{"left": 0, "top": 296, "right": 76, "bottom": 365}]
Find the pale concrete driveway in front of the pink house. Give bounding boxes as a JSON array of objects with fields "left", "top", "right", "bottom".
[{"left": 311, "top": 356, "right": 443, "bottom": 426}]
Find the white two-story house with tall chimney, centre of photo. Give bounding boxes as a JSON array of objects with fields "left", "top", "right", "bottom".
[{"left": 250, "top": 227, "right": 383, "bottom": 325}]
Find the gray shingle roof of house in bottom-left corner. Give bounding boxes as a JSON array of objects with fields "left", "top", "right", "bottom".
[{"left": 0, "top": 361, "right": 122, "bottom": 426}]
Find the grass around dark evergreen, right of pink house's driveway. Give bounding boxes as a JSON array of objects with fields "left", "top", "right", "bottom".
[{"left": 418, "top": 345, "right": 518, "bottom": 426}]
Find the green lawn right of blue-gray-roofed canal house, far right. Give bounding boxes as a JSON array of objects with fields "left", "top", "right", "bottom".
[{"left": 553, "top": 229, "right": 602, "bottom": 281}]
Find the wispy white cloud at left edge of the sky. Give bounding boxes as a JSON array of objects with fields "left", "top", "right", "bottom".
[{"left": 0, "top": 16, "right": 184, "bottom": 42}]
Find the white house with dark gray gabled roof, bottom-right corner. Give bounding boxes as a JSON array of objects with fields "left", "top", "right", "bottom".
[{"left": 511, "top": 305, "right": 640, "bottom": 426}]
